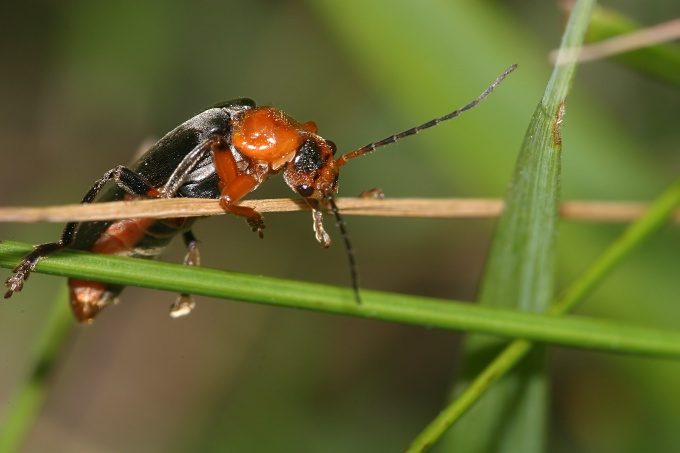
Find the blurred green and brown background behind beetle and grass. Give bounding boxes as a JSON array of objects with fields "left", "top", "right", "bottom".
[{"left": 0, "top": 0, "right": 680, "bottom": 452}]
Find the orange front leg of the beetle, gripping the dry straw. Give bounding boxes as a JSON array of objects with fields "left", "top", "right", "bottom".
[{"left": 213, "top": 137, "right": 264, "bottom": 237}]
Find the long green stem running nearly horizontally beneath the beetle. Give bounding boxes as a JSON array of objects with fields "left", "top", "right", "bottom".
[{"left": 0, "top": 241, "right": 680, "bottom": 357}]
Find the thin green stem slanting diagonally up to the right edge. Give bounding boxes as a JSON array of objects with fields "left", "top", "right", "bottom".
[{"left": 408, "top": 179, "right": 680, "bottom": 452}]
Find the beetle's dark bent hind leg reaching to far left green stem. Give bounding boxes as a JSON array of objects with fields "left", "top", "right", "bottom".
[{"left": 5, "top": 165, "right": 158, "bottom": 299}]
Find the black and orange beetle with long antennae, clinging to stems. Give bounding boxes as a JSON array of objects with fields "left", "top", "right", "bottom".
[{"left": 5, "top": 65, "right": 516, "bottom": 323}]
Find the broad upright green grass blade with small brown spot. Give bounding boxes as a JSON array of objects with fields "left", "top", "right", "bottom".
[{"left": 440, "top": 0, "right": 594, "bottom": 453}]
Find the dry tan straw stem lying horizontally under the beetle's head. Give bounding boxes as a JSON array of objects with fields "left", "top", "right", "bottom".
[{"left": 0, "top": 198, "right": 680, "bottom": 223}]
